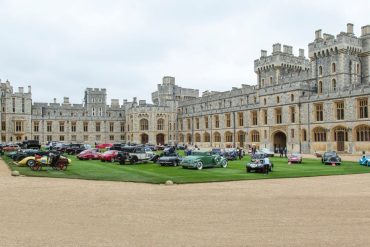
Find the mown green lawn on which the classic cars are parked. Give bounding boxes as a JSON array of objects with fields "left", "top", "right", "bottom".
[{"left": 3, "top": 152, "right": 370, "bottom": 183}]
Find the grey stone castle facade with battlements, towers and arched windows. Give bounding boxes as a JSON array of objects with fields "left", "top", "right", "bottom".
[{"left": 0, "top": 24, "right": 370, "bottom": 153}]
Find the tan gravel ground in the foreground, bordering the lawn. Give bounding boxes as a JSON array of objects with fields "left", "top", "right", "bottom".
[{"left": 0, "top": 158, "right": 370, "bottom": 246}]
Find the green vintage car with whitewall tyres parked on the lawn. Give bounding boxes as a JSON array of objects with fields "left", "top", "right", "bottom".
[{"left": 180, "top": 151, "right": 227, "bottom": 170}]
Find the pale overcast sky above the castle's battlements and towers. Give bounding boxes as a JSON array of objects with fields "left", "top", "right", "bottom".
[{"left": 0, "top": 0, "right": 370, "bottom": 104}]
